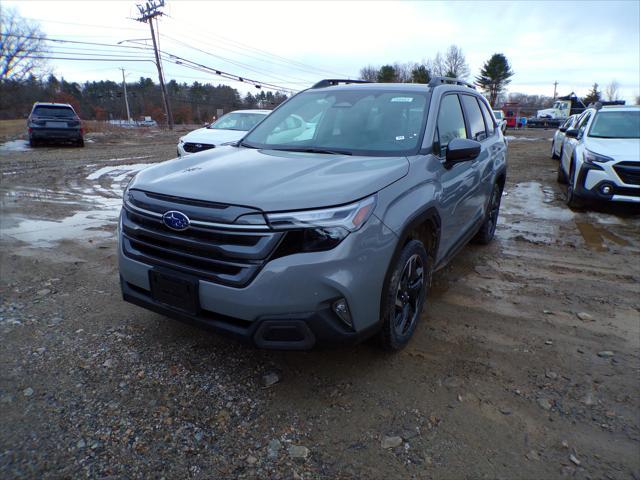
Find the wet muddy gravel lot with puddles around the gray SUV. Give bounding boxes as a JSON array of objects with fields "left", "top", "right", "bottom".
[{"left": 0, "top": 125, "right": 640, "bottom": 480}]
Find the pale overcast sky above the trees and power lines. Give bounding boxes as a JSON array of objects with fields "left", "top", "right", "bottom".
[{"left": 5, "top": 0, "right": 640, "bottom": 101}]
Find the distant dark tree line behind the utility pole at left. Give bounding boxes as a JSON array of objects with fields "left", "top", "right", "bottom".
[{"left": 0, "top": 75, "right": 287, "bottom": 124}]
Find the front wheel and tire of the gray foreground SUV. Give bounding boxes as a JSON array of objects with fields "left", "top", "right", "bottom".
[{"left": 379, "top": 240, "right": 433, "bottom": 351}]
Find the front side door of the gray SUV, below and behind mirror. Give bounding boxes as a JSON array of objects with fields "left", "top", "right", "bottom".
[{"left": 433, "top": 93, "right": 479, "bottom": 258}]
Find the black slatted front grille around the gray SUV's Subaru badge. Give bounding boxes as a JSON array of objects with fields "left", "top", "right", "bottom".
[{"left": 122, "top": 191, "right": 283, "bottom": 287}]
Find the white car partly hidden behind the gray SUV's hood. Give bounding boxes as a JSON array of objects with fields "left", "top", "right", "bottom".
[{"left": 178, "top": 110, "right": 271, "bottom": 157}]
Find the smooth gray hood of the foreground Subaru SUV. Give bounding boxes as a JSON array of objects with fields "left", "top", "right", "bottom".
[{"left": 131, "top": 146, "right": 409, "bottom": 212}]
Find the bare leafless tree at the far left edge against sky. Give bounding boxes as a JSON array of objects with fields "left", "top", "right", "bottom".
[{"left": 0, "top": 8, "right": 46, "bottom": 81}]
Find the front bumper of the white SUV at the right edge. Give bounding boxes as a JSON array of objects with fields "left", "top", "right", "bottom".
[{"left": 575, "top": 163, "right": 640, "bottom": 203}]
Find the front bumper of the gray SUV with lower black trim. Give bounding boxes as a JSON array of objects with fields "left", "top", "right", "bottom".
[{"left": 118, "top": 216, "right": 397, "bottom": 349}]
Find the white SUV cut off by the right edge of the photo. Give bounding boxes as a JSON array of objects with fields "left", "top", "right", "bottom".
[{"left": 558, "top": 106, "right": 640, "bottom": 207}]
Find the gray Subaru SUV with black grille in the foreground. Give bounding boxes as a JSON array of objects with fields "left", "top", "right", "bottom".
[{"left": 118, "top": 77, "right": 507, "bottom": 350}]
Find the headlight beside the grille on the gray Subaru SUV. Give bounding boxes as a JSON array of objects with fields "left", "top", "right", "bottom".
[{"left": 267, "top": 195, "right": 376, "bottom": 256}]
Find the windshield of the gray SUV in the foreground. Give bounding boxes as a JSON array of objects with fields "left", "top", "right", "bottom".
[{"left": 243, "top": 88, "right": 426, "bottom": 156}]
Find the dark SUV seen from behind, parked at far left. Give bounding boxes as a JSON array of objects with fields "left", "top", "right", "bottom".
[{"left": 27, "top": 102, "right": 84, "bottom": 147}]
